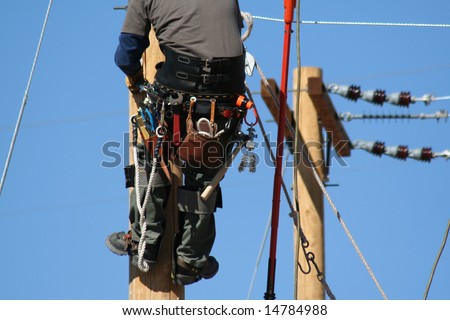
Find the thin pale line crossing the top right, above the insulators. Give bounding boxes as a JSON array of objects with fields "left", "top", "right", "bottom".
[{"left": 253, "top": 16, "right": 450, "bottom": 28}]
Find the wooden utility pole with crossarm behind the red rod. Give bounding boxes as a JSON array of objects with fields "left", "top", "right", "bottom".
[{"left": 293, "top": 67, "right": 325, "bottom": 300}]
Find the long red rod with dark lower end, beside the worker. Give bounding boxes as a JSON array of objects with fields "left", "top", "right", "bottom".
[{"left": 264, "top": 0, "right": 295, "bottom": 300}]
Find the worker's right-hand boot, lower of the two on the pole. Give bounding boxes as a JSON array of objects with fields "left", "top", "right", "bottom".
[{"left": 172, "top": 256, "right": 219, "bottom": 285}]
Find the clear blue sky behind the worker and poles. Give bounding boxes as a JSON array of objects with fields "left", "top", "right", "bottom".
[{"left": 0, "top": 0, "right": 450, "bottom": 300}]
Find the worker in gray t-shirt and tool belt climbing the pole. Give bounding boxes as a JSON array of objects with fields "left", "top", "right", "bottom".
[{"left": 106, "top": 0, "right": 245, "bottom": 285}]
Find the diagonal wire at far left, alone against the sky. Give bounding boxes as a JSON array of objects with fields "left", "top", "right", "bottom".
[{"left": 0, "top": 0, "right": 53, "bottom": 194}]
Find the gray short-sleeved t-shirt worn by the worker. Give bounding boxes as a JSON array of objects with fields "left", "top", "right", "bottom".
[{"left": 122, "top": 0, "right": 243, "bottom": 59}]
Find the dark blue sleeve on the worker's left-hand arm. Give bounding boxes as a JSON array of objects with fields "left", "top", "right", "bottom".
[{"left": 114, "top": 32, "right": 150, "bottom": 76}]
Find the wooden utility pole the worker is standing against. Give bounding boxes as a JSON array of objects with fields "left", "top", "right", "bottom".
[{"left": 129, "top": 32, "right": 184, "bottom": 300}]
